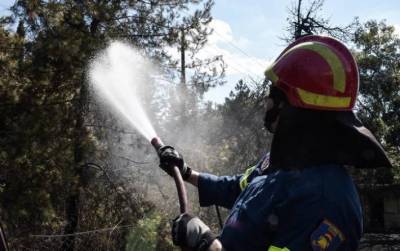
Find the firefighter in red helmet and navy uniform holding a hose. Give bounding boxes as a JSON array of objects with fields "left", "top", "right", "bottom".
[{"left": 160, "top": 35, "right": 391, "bottom": 251}]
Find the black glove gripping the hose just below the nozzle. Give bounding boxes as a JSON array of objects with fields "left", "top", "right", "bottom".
[{"left": 158, "top": 146, "right": 192, "bottom": 180}]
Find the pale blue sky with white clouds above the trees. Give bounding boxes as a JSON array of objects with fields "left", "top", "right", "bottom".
[{"left": 0, "top": 0, "right": 400, "bottom": 103}]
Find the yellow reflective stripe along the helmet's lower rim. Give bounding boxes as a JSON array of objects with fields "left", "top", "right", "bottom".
[{"left": 296, "top": 88, "right": 351, "bottom": 108}]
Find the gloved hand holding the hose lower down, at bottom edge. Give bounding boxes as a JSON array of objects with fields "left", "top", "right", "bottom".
[{"left": 172, "top": 213, "right": 216, "bottom": 251}]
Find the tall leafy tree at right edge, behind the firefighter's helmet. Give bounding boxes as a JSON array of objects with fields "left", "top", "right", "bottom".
[{"left": 353, "top": 21, "right": 400, "bottom": 180}]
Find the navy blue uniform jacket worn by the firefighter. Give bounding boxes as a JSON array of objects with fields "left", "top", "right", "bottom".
[{"left": 198, "top": 156, "right": 362, "bottom": 251}]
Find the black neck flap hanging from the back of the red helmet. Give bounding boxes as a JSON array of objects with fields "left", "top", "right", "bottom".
[{"left": 270, "top": 105, "right": 392, "bottom": 169}]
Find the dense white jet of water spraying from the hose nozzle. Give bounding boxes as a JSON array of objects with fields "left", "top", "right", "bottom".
[{"left": 89, "top": 42, "right": 156, "bottom": 141}]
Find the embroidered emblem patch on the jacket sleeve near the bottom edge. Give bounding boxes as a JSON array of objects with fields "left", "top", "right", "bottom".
[{"left": 311, "top": 219, "right": 345, "bottom": 251}]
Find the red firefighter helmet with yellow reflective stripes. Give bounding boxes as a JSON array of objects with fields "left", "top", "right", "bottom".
[{"left": 265, "top": 35, "right": 359, "bottom": 111}]
